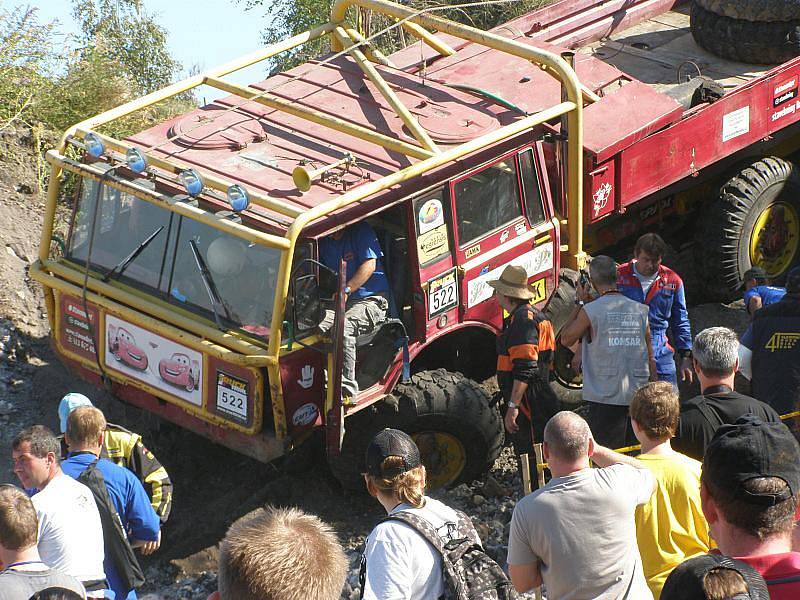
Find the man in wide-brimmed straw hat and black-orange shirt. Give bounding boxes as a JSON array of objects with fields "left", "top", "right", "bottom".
[{"left": 487, "top": 265, "right": 558, "bottom": 481}]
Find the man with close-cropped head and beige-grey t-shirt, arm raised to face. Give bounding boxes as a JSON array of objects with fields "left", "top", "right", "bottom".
[{"left": 508, "top": 411, "right": 655, "bottom": 600}]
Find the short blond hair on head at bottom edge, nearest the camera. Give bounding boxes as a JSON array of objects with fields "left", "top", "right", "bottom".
[{"left": 217, "top": 506, "right": 349, "bottom": 600}]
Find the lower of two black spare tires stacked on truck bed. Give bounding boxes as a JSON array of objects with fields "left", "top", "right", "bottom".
[{"left": 689, "top": 3, "right": 800, "bottom": 64}]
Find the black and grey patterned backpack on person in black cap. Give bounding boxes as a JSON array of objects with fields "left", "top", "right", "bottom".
[{"left": 359, "top": 510, "right": 518, "bottom": 600}]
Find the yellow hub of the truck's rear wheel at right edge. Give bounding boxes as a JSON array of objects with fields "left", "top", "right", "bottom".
[{"left": 750, "top": 202, "right": 800, "bottom": 277}]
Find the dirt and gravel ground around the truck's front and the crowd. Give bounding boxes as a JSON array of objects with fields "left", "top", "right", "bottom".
[{"left": 0, "top": 124, "right": 746, "bottom": 600}]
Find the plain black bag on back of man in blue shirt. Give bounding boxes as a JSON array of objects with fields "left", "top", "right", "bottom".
[{"left": 78, "top": 459, "right": 145, "bottom": 590}]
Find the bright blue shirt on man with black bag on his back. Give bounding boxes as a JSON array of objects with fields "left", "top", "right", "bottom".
[{"left": 61, "top": 452, "right": 161, "bottom": 600}]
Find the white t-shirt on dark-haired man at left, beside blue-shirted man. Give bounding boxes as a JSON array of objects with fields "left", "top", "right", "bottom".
[{"left": 31, "top": 471, "right": 106, "bottom": 582}]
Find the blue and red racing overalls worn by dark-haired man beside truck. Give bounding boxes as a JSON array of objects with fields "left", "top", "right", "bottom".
[{"left": 617, "top": 262, "right": 692, "bottom": 375}]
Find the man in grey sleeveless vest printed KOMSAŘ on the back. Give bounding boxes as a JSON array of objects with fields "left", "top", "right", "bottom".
[{"left": 561, "top": 256, "right": 658, "bottom": 448}]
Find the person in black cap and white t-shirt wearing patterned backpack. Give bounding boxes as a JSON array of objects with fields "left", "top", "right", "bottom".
[{"left": 360, "top": 429, "right": 516, "bottom": 600}]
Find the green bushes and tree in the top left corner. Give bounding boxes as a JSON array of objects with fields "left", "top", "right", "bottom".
[{"left": 0, "top": 0, "right": 196, "bottom": 137}]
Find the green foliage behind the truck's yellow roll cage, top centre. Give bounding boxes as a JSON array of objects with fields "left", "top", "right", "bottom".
[{"left": 244, "top": 0, "right": 554, "bottom": 71}]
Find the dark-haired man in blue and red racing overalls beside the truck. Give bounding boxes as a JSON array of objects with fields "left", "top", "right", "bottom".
[{"left": 617, "top": 233, "right": 692, "bottom": 387}]
